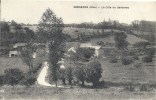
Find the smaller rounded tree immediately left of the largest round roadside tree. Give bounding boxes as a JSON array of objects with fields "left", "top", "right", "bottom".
[{"left": 73, "top": 65, "right": 86, "bottom": 86}]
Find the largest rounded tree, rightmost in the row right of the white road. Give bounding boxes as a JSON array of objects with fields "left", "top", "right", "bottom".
[{"left": 85, "top": 60, "right": 102, "bottom": 87}]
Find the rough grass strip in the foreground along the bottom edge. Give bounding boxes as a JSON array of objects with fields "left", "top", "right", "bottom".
[{"left": 0, "top": 85, "right": 155, "bottom": 100}]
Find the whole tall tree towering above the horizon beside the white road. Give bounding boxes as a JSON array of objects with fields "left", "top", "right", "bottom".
[{"left": 38, "top": 8, "right": 65, "bottom": 87}]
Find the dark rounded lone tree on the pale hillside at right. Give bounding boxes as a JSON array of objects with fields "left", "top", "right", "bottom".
[{"left": 114, "top": 32, "right": 129, "bottom": 50}]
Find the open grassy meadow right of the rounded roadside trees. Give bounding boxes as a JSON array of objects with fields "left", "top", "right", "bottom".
[{"left": 99, "top": 59, "right": 156, "bottom": 83}]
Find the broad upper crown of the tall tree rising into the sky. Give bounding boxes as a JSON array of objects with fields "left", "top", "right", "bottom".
[{"left": 38, "top": 8, "right": 63, "bottom": 42}]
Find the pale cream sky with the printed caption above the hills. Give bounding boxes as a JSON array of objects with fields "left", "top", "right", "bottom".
[{"left": 1, "top": 0, "right": 156, "bottom": 24}]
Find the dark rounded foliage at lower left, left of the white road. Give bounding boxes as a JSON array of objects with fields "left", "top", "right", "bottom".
[{"left": 4, "top": 68, "right": 24, "bottom": 86}]
